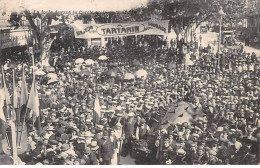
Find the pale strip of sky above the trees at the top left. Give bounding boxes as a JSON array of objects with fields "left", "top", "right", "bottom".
[{"left": 0, "top": 0, "right": 148, "bottom": 11}]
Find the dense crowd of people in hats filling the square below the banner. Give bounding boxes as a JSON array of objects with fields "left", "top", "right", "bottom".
[{"left": 1, "top": 33, "right": 260, "bottom": 165}]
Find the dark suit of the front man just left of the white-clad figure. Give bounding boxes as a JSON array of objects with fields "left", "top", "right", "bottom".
[{"left": 98, "top": 138, "right": 114, "bottom": 165}]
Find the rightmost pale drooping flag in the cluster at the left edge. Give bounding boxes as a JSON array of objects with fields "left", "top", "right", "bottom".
[{"left": 27, "top": 79, "right": 40, "bottom": 117}]
